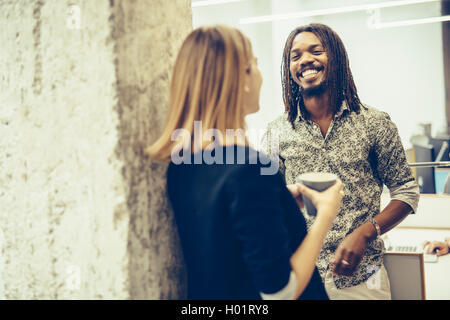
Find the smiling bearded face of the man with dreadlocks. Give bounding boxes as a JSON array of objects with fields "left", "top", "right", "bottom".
[{"left": 289, "top": 32, "right": 328, "bottom": 92}]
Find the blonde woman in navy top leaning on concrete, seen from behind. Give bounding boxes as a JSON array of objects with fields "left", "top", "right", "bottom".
[{"left": 147, "top": 25, "right": 342, "bottom": 300}]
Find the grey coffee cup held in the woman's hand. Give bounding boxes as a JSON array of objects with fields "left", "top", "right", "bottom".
[{"left": 297, "top": 172, "right": 337, "bottom": 216}]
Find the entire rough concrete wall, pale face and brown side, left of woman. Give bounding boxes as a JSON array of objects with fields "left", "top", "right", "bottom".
[{"left": 0, "top": 0, "right": 192, "bottom": 299}]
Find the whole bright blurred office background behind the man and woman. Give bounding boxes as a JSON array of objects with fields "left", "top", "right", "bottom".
[{"left": 192, "top": 0, "right": 450, "bottom": 300}]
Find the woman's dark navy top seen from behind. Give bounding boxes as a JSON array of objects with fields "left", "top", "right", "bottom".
[{"left": 167, "top": 146, "right": 327, "bottom": 299}]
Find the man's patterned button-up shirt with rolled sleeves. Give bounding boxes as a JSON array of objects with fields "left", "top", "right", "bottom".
[{"left": 263, "top": 102, "right": 419, "bottom": 288}]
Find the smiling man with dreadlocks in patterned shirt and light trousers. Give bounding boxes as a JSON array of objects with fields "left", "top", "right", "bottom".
[{"left": 264, "top": 24, "right": 419, "bottom": 299}]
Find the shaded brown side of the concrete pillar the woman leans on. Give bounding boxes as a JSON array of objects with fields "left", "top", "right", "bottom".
[{"left": 113, "top": 0, "right": 192, "bottom": 299}]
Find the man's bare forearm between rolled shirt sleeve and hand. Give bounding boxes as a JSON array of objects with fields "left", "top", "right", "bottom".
[{"left": 355, "top": 200, "right": 413, "bottom": 241}]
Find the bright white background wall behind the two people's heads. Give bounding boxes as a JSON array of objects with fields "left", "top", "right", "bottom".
[{"left": 193, "top": 0, "right": 445, "bottom": 147}]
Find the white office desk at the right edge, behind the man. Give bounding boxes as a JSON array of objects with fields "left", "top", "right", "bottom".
[{"left": 386, "top": 227, "right": 450, "bottom": 300}]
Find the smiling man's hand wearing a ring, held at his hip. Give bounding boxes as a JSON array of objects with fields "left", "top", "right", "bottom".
[{"left": 330, "top": 230, "right": 367, "bottom": 276}]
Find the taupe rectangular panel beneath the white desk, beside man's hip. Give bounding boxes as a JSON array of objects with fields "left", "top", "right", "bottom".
[{"left": 384, "top": 252, "right": 425, "bottom": 300}]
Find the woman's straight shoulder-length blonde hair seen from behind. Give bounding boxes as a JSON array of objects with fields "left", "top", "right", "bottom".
[{"left": 146, "top": 25, "right": 253, "bottom": 161}]
